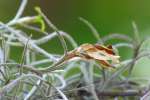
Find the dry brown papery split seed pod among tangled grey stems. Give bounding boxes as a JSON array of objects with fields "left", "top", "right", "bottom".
[{"left": 67, "top": 43, "right": 120, "bottom": 68}]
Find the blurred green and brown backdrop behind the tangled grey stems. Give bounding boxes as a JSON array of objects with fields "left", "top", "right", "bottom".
[{"left": 0, "top": 0, "right": 150, "bottom": 77}]
